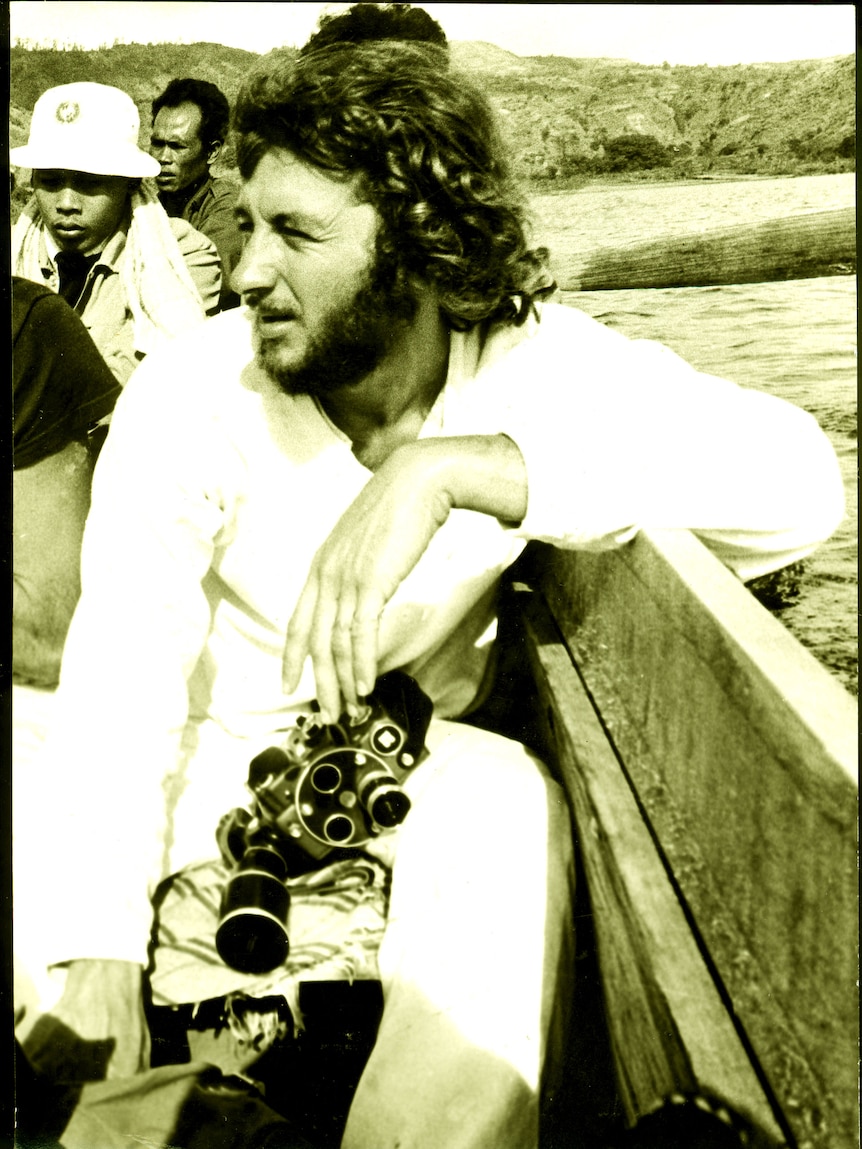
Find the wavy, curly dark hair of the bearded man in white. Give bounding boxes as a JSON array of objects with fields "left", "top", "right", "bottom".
[{"left": 234, "top": 40, "right": 554, "bottom": 330}]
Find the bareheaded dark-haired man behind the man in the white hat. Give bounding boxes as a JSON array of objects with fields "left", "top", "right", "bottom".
[{"left": 149, "top": 78, "right": 241, "bottom": 311}]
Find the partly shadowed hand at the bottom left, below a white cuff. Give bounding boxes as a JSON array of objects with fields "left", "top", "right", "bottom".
[{"left": 23, "top": 961, "right": 149, "bottom": 1082}]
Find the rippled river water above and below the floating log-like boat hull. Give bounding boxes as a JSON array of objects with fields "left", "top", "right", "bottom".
[{"left": 532, "top": 173, "right": 859, "bottom": 694}]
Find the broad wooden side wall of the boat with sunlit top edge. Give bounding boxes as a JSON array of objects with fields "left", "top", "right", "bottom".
[{"left": 537, "top": 531, "right": 859, "bottom": 1147}]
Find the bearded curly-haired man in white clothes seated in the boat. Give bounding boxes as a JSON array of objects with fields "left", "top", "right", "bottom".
[{"left": 22, "top": 40, "right": 842, "bottom": 1149}]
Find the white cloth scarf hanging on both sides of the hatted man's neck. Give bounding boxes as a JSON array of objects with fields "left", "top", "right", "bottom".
[{"left": 11, "top": 179, "right": 206, "bottom": 355}]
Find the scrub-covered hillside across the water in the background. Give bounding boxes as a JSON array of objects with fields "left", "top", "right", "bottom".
[{"left": 9, "top": 43, "right": 855, "bottom": 186}]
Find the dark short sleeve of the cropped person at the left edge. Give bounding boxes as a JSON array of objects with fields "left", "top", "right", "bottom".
[{"left": 11, "top": 277, "right": 121, "bottom": 468}]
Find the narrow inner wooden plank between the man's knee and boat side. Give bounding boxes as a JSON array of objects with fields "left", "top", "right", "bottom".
[{"left": 512, "top": 595, "right": 785, "bottom": 1144}]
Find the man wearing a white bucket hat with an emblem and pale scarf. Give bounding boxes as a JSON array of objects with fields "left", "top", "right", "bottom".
[{"left": 9, "top": 82, "right": 222, "bottom": 384}]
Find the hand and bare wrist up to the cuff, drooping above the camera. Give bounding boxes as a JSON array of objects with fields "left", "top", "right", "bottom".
[{"left": 283, "top": 435, "right": 526, "bottom": 722}]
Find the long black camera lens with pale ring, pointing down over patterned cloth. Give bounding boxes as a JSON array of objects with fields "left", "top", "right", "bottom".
[{"left": 216, "top": 846, "right": 291, "bottom": 973}]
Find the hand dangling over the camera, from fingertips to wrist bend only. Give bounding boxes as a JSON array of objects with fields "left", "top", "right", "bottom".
[{"left": 283, "top": 444, "right": 453, "bottom": 722}]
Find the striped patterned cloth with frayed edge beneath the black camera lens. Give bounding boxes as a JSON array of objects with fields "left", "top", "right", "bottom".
[{"left": 151, "top": 855, "right": 390, "bottom": 1027}]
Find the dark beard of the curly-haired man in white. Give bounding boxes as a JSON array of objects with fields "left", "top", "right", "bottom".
[{"left": 257, "top": 240, "right": 418, "bottom": 396}]
